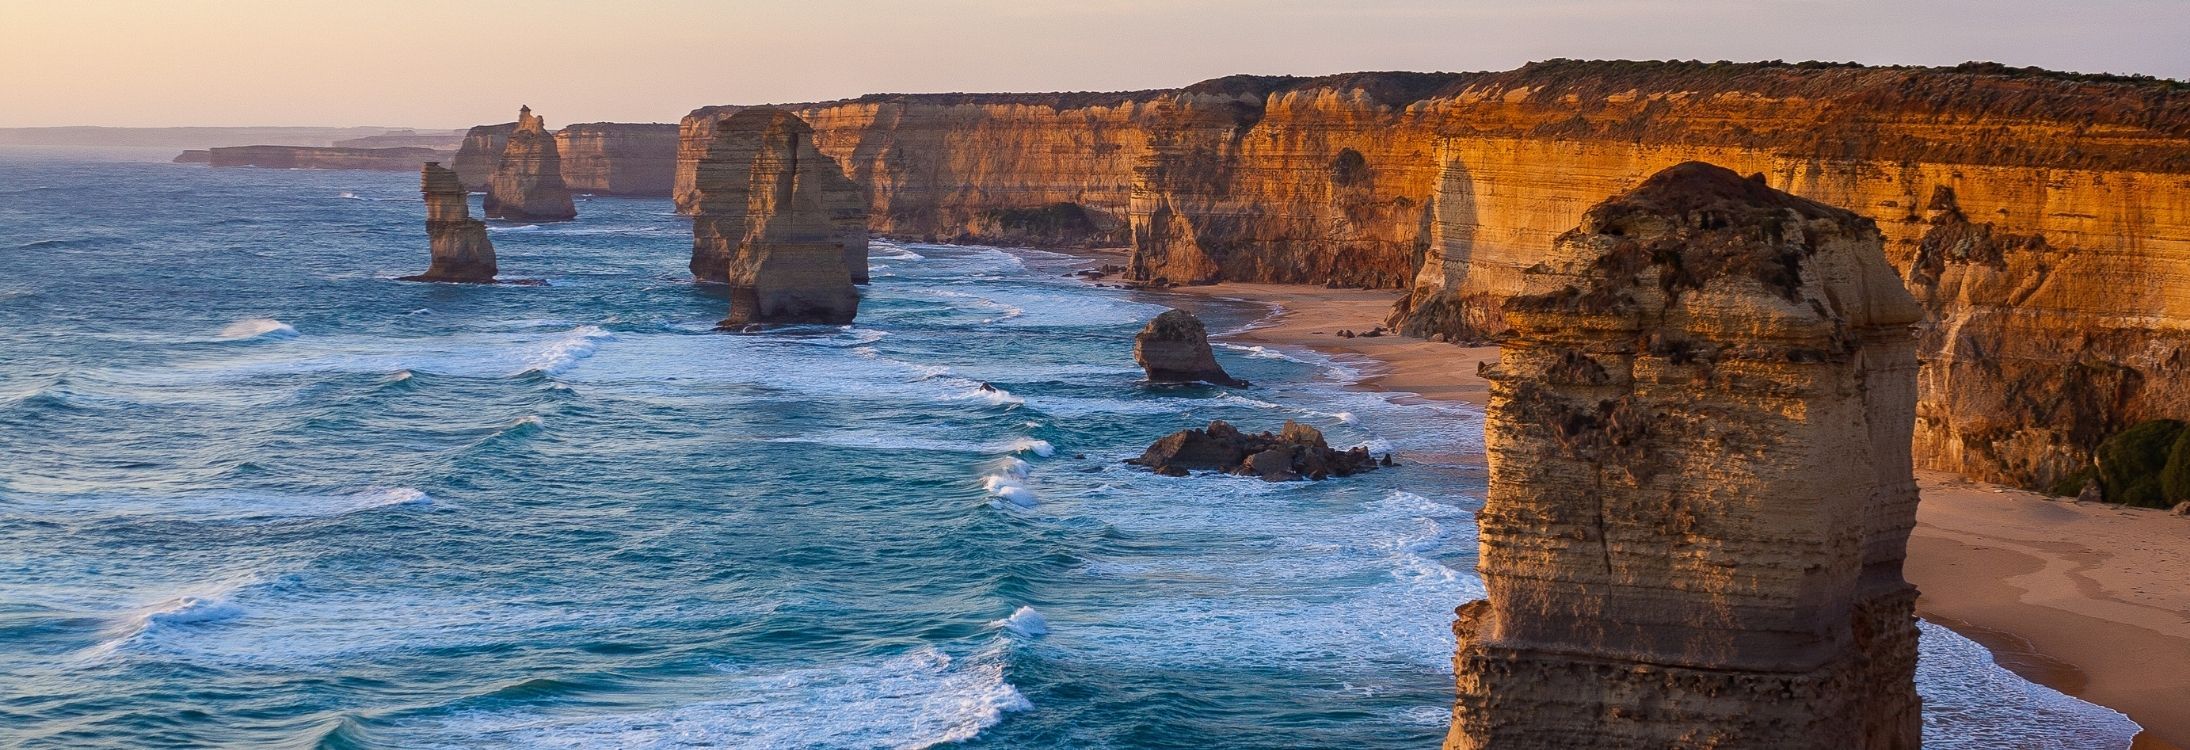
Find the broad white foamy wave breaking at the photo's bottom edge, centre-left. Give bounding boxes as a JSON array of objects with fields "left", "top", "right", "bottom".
[{"left": 418, "top": 645, "right": 1034, "bottom": 750}]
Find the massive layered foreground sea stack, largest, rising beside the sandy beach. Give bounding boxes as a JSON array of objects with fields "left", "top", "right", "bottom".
[{"left": 1445, "top": 162, "right": 1921, "bottom": 750}]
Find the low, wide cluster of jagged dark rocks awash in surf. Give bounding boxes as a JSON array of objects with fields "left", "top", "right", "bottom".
[{"left": 1126, "top": 419, "right": 1391, "bottom": 482}]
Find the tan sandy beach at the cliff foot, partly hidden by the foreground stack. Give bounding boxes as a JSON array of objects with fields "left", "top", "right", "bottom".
[{"left": 1176, "top": 283, "right": 2190, "bottom": 750}]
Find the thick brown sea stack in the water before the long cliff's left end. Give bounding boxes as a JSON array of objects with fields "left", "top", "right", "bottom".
[{"left": 692, "top": 107, "right": 867, "bottom": 329}]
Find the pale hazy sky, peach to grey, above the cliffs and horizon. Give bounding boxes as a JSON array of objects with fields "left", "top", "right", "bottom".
[{"left": 0, "top": 0, "right": 2190, "bottom": 127}]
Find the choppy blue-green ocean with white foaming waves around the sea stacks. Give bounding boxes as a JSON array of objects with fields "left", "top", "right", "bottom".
[{"left": 0, "top": 147, "right": 2135, "bottom": 748}]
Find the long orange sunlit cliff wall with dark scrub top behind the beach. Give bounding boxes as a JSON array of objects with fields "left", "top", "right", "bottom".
[{"left": 677, "top": 61, "right": 2190, "bottom": 485}]
